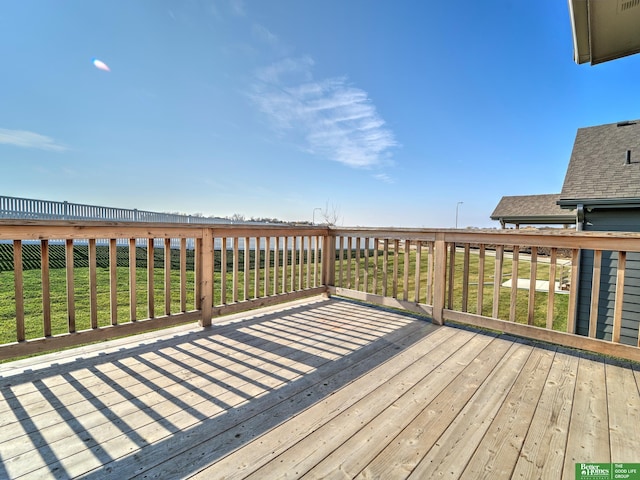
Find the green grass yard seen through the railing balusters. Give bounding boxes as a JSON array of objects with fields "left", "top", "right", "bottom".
[{"left": 0, "top": 246, "right": 568, "bottom": 343}]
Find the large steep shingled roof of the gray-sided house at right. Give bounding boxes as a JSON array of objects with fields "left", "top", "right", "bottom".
[{"left": 560, "top": 120, "right": 640, "bottom": 207}]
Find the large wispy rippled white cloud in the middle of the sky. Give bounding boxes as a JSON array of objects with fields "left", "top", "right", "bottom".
[{"left": 251, "top": 57, "right": 397, "bottom": 167}]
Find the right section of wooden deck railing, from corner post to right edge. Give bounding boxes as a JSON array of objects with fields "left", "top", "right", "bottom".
[{"left": 330, "top": 229, "right": 640, "bottom": 360}]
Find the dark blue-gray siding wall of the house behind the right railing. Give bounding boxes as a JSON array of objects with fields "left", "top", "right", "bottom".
[{"left": 576, "top": 208, "right": 640, "bottom": 345}]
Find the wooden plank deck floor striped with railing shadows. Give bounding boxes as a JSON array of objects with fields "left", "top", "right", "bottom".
[{"left": 0, "top": 298, "right": 640, "bottom": 479}]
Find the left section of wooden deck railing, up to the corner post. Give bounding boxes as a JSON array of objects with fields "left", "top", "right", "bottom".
[{"left": 0, "top": 220, "right": 328, "bottom": 359}]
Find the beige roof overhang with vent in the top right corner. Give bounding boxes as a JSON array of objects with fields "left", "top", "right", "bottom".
[{"left": 568, "top": 0, "right": 640, "bottom": 65}]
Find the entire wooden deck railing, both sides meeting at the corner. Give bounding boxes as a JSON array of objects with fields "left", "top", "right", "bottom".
[{"left": 0, "top": 220, "right": 640, "bottom": 360}]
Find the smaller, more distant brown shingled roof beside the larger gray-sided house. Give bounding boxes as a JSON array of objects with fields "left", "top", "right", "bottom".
[{"left": 491, "top": 193, "right": 576, "bottom": 225}]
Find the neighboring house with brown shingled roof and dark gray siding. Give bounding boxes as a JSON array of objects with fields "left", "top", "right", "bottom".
[{"left": 558, "top": 120, "right": 640, "bottom": 345}]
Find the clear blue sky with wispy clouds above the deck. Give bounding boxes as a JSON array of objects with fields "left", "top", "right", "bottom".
[{"left": 0, "top": 0, "right": 640, "bottom": 227}]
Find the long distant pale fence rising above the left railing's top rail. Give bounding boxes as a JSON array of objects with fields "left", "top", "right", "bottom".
[{"left": 0, "top": 196, "right": 229, "bottom": 224}]
